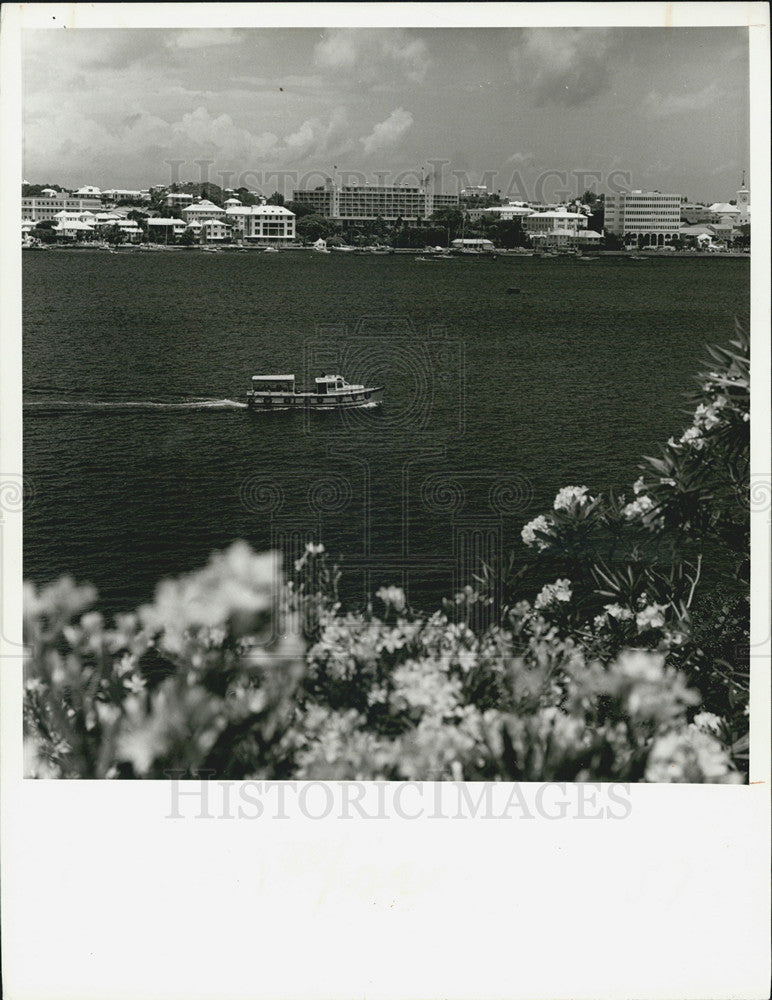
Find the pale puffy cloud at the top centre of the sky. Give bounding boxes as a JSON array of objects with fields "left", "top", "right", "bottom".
[{"left": 314, "top": 28, "right": 431, "bottom": 83}]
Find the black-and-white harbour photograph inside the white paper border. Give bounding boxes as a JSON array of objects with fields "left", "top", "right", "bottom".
[{"left": 16, "top": 11, "right": 769, "bottom": 783}]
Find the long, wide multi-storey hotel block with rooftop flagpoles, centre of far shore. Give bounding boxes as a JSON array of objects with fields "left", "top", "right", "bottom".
[{"left": 292, "top": 181, "right": 458, "bottom": 225}]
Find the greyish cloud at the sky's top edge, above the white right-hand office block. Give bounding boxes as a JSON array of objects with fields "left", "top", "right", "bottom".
[{"left": 510, "top": 28, "right": 617, "bottom": 108}]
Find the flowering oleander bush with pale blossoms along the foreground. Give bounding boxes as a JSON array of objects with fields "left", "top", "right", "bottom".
[{"left": 24, "top": 329, "right": 749, "bottom": 783}]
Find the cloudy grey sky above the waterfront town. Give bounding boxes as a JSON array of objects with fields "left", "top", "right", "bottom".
[{"left": 22, "top": 28, "right": 749, "bottom": 203}]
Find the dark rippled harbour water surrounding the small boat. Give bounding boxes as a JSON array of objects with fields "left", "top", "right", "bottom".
[{"left": 24, "top": 251, "right": 749, "bottom": 610}]
